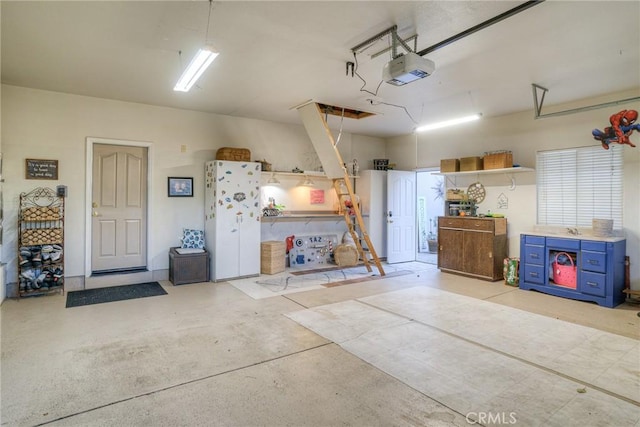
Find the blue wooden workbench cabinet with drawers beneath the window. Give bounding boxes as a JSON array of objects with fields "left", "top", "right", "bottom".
[{"left": 519, "top": 234, "right": 626, "bottom": 308}]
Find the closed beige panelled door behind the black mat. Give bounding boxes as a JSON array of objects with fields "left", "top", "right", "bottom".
[{"left": 91, "top": 144, "right": 147, "bottom": 272}]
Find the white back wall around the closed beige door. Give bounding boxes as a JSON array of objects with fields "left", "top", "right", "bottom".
[{"left": 0, "top": 85, "right": 385, "bottom": 296}]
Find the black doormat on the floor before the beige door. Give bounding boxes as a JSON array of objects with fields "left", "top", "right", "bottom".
[{"left": 67, "top": 282, "right": 167, "bottom": 308}]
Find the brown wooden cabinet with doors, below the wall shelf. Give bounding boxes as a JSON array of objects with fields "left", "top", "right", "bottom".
[{"left": 438, "top": 216, "right": 507, "bottom": 280}]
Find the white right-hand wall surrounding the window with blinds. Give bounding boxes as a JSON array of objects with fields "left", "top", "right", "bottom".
[{"left": 387, "top": 90, "right": 640, "bottom": 290}]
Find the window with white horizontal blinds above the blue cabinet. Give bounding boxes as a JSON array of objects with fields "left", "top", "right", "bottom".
[{"left": 536, "top": 145, "right": 623, "bottom": 229}]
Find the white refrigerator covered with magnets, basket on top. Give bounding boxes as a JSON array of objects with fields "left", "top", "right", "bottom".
[{"left": 205, "top": 160, "right": 261, "bottom": 282}]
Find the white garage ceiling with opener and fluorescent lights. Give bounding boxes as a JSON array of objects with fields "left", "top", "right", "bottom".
[{"left": 0, "top": 0, "right": 640, "bottom": 137}]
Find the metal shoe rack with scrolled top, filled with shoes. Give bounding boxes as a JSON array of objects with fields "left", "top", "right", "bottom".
[{"left": 18, "top": 187, "right": 64, "bottom": 297}]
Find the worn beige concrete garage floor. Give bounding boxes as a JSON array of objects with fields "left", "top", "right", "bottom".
[{"left": 0, "top": 263, "right": 640, "bottom": 427}]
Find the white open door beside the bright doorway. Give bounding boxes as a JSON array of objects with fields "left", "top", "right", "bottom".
[{"left": 387, "top": 170, "right": 416, "bottom": 264}]
